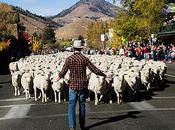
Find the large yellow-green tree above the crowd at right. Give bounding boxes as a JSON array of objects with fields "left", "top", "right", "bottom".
[{"left": 114, "top": 0, "right": 164, "bottom": 39}]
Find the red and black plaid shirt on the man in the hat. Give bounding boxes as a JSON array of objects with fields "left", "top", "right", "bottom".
[{"left": 59, "top": 52, "right": 106, "bottom": 90}]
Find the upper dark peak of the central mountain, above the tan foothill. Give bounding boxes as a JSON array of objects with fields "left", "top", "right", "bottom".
[{"left": 50, "top": 0, "right": 118, "bottom": 25}]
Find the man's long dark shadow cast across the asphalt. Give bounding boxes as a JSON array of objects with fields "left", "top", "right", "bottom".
[{"left": 86, "top": 111, "right": 143, "bottom": 130}]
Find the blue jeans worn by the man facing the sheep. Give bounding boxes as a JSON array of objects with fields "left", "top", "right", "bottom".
[{"left": 68, "top": 87, "right": 86, "bottom": 129}]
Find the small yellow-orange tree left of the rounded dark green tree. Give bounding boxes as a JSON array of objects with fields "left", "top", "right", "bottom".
[{"left": 32, "top": 37, "right": 42, "bottom": 52}]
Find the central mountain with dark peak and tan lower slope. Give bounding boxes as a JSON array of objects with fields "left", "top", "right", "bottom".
[{"left": 50, "top": 0, "right": 119, "bottom": 39}]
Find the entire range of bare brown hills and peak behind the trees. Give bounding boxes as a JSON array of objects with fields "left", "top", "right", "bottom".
[{"left": 0, "top": 0, "right": 119, "bottom": 39}]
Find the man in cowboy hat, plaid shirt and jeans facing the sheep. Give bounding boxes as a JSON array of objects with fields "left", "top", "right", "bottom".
[{"left": 57, "top": 40, "right": 106, "bottom": 130}]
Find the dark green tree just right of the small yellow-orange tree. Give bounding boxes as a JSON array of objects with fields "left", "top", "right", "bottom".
[{"left": 42, "top": 27, "right": 56, "bottom": 44}]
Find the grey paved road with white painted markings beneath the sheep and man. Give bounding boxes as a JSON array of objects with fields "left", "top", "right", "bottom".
[{"left": 0, "top": 64, "right": 175, "bottom": 130}]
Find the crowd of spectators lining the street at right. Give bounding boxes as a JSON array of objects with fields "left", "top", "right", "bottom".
[{"left": 119, "top": 42, "right": 175, "bottom": 63}]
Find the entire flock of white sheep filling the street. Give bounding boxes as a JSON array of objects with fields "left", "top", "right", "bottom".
[{"left": 9, "top": 52, "right": 167, "bottom": 105}]
